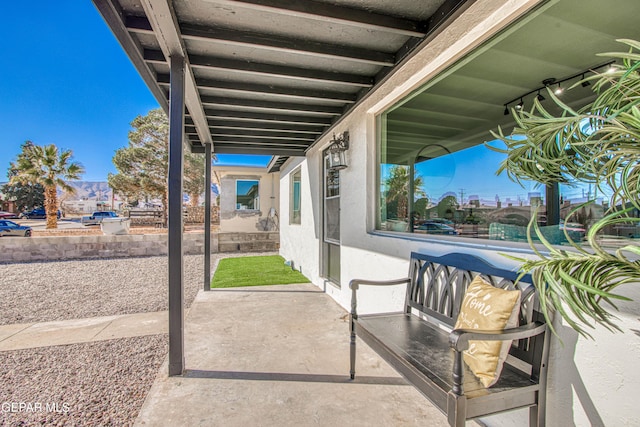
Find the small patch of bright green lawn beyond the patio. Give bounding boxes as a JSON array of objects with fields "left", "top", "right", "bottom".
[{"left": 211, "top": 255, "right": 309, "bottom": 288}]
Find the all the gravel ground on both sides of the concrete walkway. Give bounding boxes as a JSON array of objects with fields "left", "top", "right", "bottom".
[{"left": 0, "top": 252, "right": 273, "bottom": 426}]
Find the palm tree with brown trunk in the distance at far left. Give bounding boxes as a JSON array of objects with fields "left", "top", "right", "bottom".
[{"left": 11, "top": 144, "right": 84, "bottom": 228}]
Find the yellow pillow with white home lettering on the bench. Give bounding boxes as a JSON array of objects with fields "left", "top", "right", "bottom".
[{"left": 455, "top": 276, "right": 521, "bottom": 387}]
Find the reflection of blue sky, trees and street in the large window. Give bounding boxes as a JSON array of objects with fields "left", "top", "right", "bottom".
[{"left": 376, "top": 113, "right": 640, "bottom": 247}]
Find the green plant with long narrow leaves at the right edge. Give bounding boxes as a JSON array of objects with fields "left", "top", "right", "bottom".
[{"left": 494, "top": 40, "right": 640, "bottom": 336}]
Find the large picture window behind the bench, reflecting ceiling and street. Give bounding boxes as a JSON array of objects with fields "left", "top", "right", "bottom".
[{"left": 375, "top": 2, "right": 640, "bottom": 248}]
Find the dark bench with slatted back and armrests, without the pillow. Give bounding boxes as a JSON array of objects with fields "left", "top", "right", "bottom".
[{"left": 349, "top": 252, "right": 549, "bottom": 426}]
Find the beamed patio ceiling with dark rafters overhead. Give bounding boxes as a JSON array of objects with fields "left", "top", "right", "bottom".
[{"left": 93, "top": 0, "right": 474, "bottom": 165}]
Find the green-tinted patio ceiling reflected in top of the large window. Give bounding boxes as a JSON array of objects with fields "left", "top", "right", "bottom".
[{"left": 385, "top": 0, "right": 640, "bottom": 164}]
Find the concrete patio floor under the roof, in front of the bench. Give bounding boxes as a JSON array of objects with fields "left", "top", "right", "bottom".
[{"left": 135, "top": 284, "right": 448, "bottom": 427}]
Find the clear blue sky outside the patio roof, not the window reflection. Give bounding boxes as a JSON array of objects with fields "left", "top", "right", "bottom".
[{"left": 0, "top": 0, "right": 270, "bottom": 182}]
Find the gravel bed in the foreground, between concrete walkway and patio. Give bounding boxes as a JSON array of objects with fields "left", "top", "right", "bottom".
[{"left": 0, "top": 335, "right": 168, "bottom": 426}]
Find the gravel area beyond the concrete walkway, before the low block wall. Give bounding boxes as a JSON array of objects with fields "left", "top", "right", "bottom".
[{"left": 0, "top": 253, "right": 273, "bottom": 325}]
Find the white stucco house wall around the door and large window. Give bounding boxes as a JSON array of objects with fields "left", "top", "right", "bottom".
[{"left": 280, "top": 0, "right": 640, "bottom": 427}]
